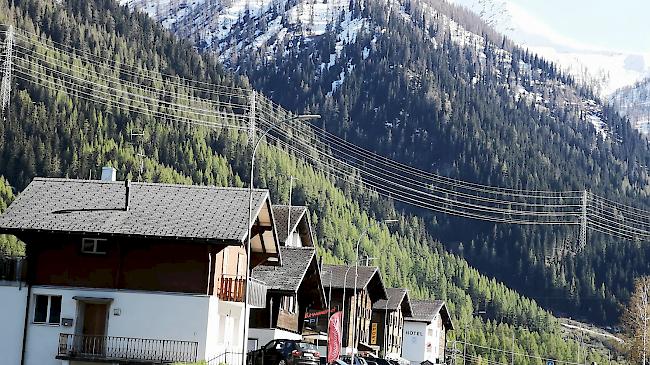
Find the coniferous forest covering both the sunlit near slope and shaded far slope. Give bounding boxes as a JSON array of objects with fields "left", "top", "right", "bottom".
[{"left": 0, "top": 0, "right": 636, "bottom": 364}]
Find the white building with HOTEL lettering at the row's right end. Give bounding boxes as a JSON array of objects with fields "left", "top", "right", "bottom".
[{"left": 402, "top": 300, "right": 453, "bottom": 365}]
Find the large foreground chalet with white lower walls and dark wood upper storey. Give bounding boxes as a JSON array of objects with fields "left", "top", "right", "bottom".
[{"left": 0, "top": 171, "right": 282, "bottom": 365}]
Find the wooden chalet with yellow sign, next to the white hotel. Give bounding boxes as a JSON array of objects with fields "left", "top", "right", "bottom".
[{"left": 370, "top": 288, "right": 413, "bottom": 359}]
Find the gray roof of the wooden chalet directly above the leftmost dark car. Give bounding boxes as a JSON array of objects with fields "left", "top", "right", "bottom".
[{"left": 252, "top": 247, "right": 316, "bottom": 293}]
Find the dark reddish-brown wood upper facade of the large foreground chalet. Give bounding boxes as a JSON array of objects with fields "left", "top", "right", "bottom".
[{"left": 21, "top": 233, "right": 258, "bottom": 295}]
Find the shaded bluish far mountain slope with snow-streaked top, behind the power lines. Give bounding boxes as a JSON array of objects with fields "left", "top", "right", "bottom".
[{"left": 119, "top": 0, "right": 650, "bottom": 323}]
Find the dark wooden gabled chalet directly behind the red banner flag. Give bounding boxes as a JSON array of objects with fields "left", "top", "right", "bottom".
[{"left": 321, "top": 265, "right": 388, "bottom": 354}]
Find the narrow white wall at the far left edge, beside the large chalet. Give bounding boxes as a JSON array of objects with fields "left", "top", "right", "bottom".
[{"left": 0, "top": 281, "right": 27, "bottom": 365}]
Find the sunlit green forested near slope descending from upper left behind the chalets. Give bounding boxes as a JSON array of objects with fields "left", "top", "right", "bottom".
[{"left": 0, "top": 0, "right": 624, "bottom": 364}]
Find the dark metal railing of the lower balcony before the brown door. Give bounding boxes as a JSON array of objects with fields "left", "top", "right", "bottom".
[{"left": 57, "top": 333, "right": 199, "bottom": 364}]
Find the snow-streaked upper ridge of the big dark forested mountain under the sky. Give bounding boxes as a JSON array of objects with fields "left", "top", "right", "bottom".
[{"left": 122, "top": 0, "right": 608, "bottom": 138}]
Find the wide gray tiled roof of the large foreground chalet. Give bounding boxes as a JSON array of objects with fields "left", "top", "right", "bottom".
[{"left": 0, "top": 178, "right": 268, "bottom": 241}]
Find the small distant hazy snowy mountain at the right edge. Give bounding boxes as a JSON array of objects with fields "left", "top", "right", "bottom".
[{"left": 610, "top": 77, "right": 650, "bottom": 134}]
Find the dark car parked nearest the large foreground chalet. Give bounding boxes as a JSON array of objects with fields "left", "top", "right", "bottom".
[{"left": 247, "top": 340, "right": 320, "bottom": 365}]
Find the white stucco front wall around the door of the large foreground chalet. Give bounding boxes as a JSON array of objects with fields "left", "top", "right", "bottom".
[{"left": 21, "top": 287, "right": 214, "bottom": 365}]
